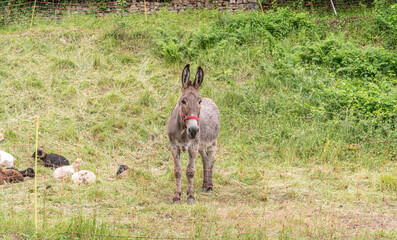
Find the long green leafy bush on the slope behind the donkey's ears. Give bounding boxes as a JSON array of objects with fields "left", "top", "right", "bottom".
[{"left": 156, "top": 9, "right": 315, "bottom": 62}]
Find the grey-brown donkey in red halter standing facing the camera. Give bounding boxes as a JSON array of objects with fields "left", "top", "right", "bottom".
[{"left": 167, "top": 64, "right": 220, "bottom": 204}]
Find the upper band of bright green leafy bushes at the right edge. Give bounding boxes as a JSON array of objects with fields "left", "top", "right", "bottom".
[{"left": 278, "top": 38, "right": 397, "bottom": 78}]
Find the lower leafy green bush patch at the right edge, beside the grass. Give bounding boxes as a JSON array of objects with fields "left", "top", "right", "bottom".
[{"left": 313, "top": 78, "right": 397, "bottom": 124}]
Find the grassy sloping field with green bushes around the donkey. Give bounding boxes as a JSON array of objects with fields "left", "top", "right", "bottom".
[{"left": 0, "top": 7, "right": 397, "bottom": 239}]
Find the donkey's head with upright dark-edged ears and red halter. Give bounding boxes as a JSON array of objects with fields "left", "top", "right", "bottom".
[{"left": 179, "top": 64, "right": 204, "bottom": 139}]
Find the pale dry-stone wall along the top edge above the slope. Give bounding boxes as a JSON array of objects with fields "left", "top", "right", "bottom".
[{"left": 128, "top": 0, "right": 258, "bottom": 14}]
